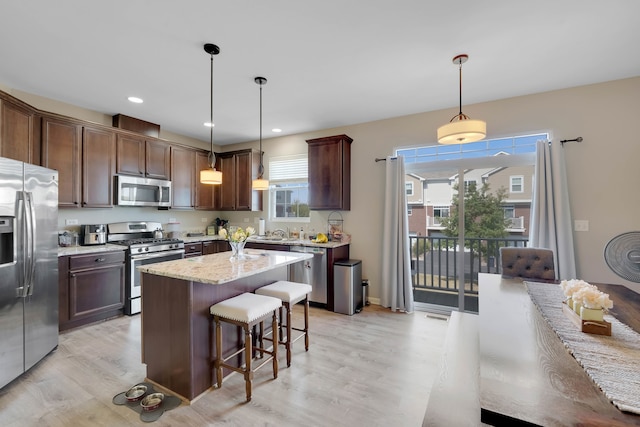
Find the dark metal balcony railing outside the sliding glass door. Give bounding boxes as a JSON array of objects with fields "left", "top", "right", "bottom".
[{"left": 409, "top": 236, "right": 528, "bottom": 295}]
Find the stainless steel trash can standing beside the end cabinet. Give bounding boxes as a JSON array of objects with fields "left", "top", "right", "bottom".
[{"left": 333, "top": 259, "right": 363, "bottom": 315}]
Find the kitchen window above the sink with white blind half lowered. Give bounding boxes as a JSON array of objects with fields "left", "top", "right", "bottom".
[{"left": 269, "top": 154, "right": 309, "bottom": 222}]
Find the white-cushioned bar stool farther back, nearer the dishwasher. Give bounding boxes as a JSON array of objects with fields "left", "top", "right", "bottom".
[{"left": 256, "top": 280, "right": 312, "bottom": 366}]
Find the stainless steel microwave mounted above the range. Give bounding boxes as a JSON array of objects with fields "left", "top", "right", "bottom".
[{"left": 115, "top": 175, "right": 171, "bottom": 207}]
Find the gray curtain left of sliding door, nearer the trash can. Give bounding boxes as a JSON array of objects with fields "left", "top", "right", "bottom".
[{"left": 380, "top": 156, "right": 413, "bottom": 313}]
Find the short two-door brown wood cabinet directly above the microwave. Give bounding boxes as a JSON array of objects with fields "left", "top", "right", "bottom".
[{"left": 116, "top": 133, "right": 171, "bottom": 179}]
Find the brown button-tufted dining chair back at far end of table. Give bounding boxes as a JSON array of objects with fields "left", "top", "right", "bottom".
[{"left": 500, "top": 247, "right": 556, "bottom": 281}]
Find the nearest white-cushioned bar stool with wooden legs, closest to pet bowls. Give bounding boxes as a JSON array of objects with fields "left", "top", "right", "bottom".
[{"left": 210, "top": 293, "right": 282, "bottom": 402}]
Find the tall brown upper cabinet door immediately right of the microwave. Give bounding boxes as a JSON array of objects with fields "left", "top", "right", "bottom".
[{"left": 171, "top": 147, "right": 196, "bottom": 209}]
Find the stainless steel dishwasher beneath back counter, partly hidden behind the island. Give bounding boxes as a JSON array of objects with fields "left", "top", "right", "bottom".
[{"left": 289, "top": 246, "right": 327, "bottom": 306}]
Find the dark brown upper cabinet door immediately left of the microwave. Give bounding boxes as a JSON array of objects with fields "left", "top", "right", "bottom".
[{"left": 82, "top": 127, "right": 116, "bottom": 208}]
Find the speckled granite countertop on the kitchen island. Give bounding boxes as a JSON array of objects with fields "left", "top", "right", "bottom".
[{"left": 138, "top": 249, "right": 313, "bottom": 285}]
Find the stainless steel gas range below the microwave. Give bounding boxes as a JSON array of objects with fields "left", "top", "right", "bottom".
[{"left": 107, "top": 221, "right": 184, "bottom": 315}]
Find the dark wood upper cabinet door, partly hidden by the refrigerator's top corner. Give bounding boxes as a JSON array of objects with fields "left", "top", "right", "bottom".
[{"left": 42, "top": 116, "right": 82, "bottom": 208}]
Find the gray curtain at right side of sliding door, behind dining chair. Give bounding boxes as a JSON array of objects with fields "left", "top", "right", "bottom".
[{"left": 529, "top": 141, "right": 576, "bottom": 280}]
